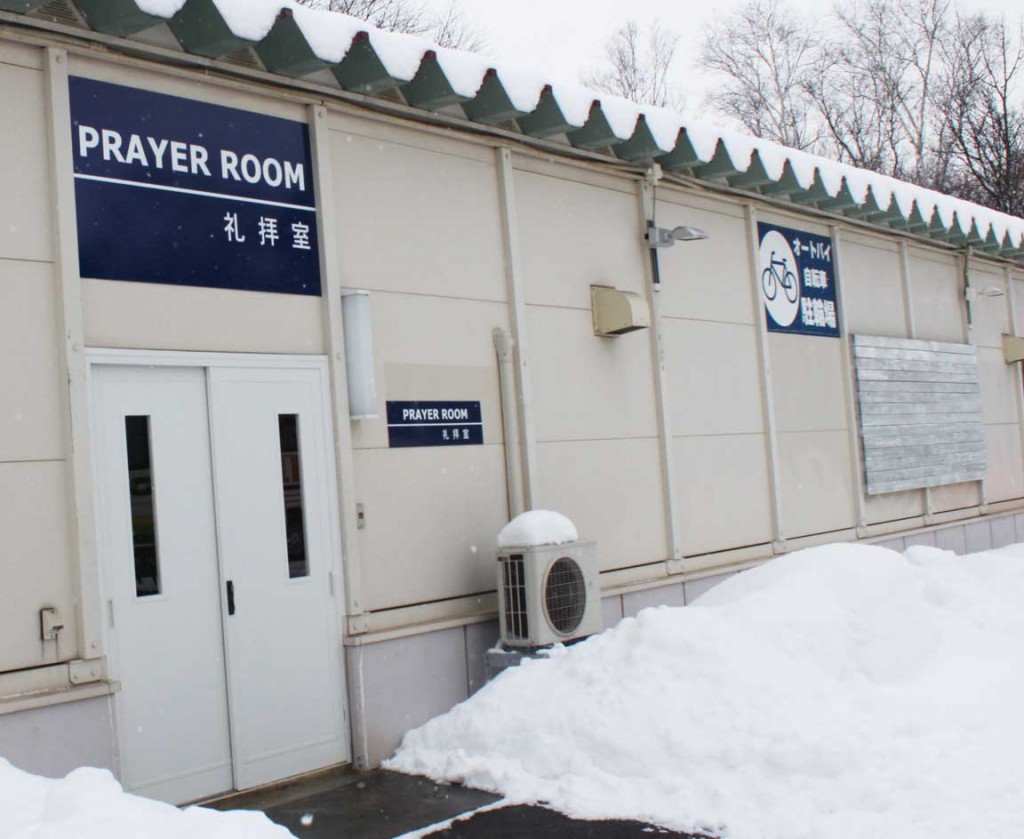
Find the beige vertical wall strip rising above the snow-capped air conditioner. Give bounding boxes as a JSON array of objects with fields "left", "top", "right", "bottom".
[{"left": 495, "top": 146, "right": 537, "bottom": 510}]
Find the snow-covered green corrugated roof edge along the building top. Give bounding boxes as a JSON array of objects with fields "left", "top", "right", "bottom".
[{"left": 15, "top": 0, "right": 1024, "bottom": 261}]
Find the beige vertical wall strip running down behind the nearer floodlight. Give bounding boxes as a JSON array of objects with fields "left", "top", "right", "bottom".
[{"left": 637, "top": 180, "right": 686, "bottom": 573}]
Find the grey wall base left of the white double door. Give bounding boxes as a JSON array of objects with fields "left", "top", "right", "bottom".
[{"left": 0, "top": 697, "right": 114, "bottom": 778}]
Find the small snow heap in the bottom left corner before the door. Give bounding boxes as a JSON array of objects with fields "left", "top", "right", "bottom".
[{"left": 0, "top": 758, "right": 292, "bottom": 839}]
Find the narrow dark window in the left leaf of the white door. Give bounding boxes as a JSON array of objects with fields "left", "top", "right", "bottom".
[{"left": 125, "top": 417, "right": 160, "bottom": 597}]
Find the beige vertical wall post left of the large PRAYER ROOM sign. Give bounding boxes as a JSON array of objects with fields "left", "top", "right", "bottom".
[{"left": 45, "top": 47, "right": 102, "bottom": 659}]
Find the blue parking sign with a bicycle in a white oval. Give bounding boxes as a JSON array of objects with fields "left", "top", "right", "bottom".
[{"left": 758, "top": 222, "right": 839, "bottom": 338}]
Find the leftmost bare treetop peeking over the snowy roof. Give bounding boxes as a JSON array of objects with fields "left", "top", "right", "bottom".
[{"left": 298, "top": 0, "right": 486, "bottom": 50}]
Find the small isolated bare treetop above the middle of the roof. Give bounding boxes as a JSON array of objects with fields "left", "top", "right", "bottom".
[{"left": 581, "top": 20, "right": 685, "bottom": 110}]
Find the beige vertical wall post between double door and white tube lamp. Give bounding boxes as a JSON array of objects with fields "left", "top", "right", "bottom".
[{"left": 308, "top": 104, "right": 368, "bottom": 634}]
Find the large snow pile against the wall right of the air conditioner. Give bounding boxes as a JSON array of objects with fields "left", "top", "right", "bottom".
[{"left": 390, "top": 545, "right": 1024, "bottom": 839}]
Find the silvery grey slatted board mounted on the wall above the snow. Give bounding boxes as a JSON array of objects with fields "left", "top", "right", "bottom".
[{"left": 853, "top": 335, "right": 986, "bottom": 495}]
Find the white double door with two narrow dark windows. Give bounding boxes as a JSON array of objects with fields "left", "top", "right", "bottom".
[{"left": 91, "top": 363, "right": 349, "bottom": 803}]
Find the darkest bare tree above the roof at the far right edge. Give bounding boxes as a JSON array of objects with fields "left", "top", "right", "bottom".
[{"left": 944, "top": 14, "right": 1024, "bottom": 215}]
